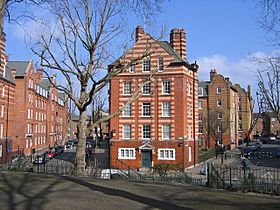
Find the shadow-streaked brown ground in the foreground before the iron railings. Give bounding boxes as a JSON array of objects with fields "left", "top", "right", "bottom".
[{"left": 0, "top": 172, "right": 280, "bottom": 210}]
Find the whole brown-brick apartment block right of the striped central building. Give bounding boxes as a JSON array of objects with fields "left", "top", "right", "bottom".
[{"left": 198, "top": 69, "right": 252, "bottom": 149}]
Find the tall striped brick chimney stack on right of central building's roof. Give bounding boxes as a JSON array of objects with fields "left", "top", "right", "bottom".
[{"left": 170, "top": 28, "right": 187, "bottom": 60}]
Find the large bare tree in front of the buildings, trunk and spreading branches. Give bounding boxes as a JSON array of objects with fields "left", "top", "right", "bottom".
[{"left": 33, "top": 0, "right": 164, "bottom": 174}]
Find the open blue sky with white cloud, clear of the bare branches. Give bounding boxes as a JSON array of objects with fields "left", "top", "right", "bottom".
[{"left": 2, "top": 0, "right": 275, "bottom": 94}]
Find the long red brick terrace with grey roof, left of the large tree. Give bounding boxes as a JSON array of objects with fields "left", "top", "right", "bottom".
[{"left": 6, "top": 61, "right": 67, "bottom": 154}]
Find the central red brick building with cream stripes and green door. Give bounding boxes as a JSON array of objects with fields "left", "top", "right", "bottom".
[{"left": 109, "top": 26, "right": 198, "bottom": 168}]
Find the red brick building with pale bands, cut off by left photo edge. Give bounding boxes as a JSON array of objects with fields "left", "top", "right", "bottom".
[{"left": 0, "top": 33, "right": 15, "bottom": 163}]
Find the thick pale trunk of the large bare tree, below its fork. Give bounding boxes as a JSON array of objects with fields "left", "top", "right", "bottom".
[{"left": 75, "top": 110, "right": 87, "bottom": 175}]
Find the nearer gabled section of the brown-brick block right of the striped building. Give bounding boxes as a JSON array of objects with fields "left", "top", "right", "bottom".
[{"left": 198, "top": 69, "right": 238, "bottom": 149}]
